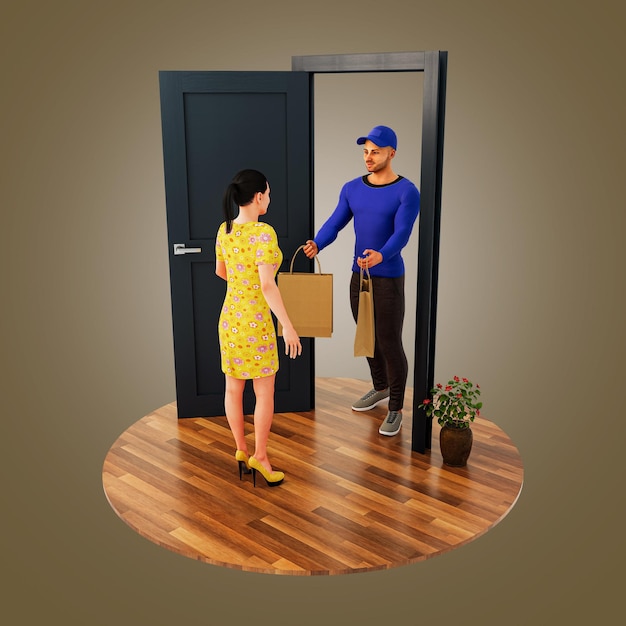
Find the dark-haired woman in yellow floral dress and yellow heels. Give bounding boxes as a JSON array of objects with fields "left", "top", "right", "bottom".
[{"left": 215, "top": 170, "right": 302, "bottom": 486}]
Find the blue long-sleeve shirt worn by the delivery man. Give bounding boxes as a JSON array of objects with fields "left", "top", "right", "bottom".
[{"left": 314, "top": 176, "right": 420, "bottom": 278}]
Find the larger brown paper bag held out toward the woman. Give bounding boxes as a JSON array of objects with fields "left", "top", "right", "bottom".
[{"left": 278, "top": 246, "right": 333, "bottom": 337}]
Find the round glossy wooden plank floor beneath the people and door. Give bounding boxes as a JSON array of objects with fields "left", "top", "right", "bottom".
[{"left": 102, "top": 378, "right": 523, "bottom": 575}]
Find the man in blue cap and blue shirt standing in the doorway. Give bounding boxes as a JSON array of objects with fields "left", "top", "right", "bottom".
[{"left": 304, "top": 126, "right": 420, "bottom": 436}]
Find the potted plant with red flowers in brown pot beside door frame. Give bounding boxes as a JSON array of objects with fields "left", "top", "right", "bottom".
[{"left": 419, "top": 376, "right": 483, "bottom": 467}]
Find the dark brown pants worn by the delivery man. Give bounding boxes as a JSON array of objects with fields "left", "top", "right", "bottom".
[{"left": 350, "top": 272, "right": 409, "bottom": 411}]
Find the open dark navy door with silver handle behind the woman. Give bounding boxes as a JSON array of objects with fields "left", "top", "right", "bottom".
[{"left": 159, "top": 72, "right": 314, "bottom": 417}]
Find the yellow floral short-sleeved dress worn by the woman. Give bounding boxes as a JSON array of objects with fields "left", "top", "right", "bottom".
[{"left": 215, "top": 222, "right": 283, "bottom": 379}]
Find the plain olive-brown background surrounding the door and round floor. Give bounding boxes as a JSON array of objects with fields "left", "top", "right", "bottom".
[{"left": 0, "top": 0, "right": 626, "bottom": 626}]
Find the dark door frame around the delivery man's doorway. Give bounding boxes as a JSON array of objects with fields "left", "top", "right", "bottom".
[{"left": 291, "top": 50, "right": 448, "bottom": 453}]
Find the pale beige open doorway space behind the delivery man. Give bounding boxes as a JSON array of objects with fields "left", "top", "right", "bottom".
[{"left": 313, "top": 72, "right": 424, "bottom": 386}]
